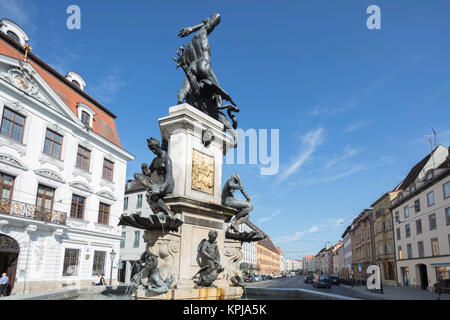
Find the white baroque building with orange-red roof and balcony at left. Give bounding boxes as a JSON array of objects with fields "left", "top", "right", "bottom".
[{"left": 0, "top": 19, "right": 134, "bottom": 294}]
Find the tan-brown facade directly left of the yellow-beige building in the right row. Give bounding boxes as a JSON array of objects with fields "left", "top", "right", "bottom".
[{"left": 350, "top": 209, "right": 375, "bottom": 279}]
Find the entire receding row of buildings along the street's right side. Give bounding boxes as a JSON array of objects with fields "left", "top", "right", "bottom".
[{"left": 304, "top": 145, "right": 450, "bottom": 290}]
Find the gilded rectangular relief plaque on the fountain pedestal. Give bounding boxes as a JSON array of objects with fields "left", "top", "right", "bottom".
[{"left": 191, "top": 149, "right": 214, "bottom": 194}]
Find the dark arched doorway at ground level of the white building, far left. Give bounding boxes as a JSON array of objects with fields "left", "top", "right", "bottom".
[{"left": 0, "top": 234, "right": 20, "bottom": 294}]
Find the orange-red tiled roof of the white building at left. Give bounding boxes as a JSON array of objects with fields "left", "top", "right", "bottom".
[{"left": 0, "top": 32, "right": 123, "bottom": 148}]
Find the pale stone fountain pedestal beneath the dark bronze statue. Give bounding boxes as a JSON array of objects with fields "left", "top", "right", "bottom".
[{"left": 134, "top": 104, "right": 243, "bottom": 300}]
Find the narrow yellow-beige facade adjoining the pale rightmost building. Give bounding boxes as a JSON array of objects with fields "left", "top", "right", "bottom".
[{"left": 372, "top": 191, "right": 398, "bottom": 286}]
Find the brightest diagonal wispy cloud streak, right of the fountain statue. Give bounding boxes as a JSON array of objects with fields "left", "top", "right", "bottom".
[{"left": 278, "top": 128, "right": 325, "bottom": 182}]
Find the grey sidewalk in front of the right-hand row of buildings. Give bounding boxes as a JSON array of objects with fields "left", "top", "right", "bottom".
[{"left": 341, "top": 284, "right": 450, "bottom": 300}]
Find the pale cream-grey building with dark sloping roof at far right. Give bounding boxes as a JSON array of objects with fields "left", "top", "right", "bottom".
[{"left": 391, "top": 147, "right": 450, "bottom": 290}]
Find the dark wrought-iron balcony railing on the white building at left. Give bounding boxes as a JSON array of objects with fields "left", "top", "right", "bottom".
[{"left": 0, "top": 199, "right": 67, "bottom": 225}]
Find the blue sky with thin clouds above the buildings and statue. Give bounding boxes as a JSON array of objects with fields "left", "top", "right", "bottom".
[{"left": 0, "top": 0, "right": 450, "bottom": 258}]
